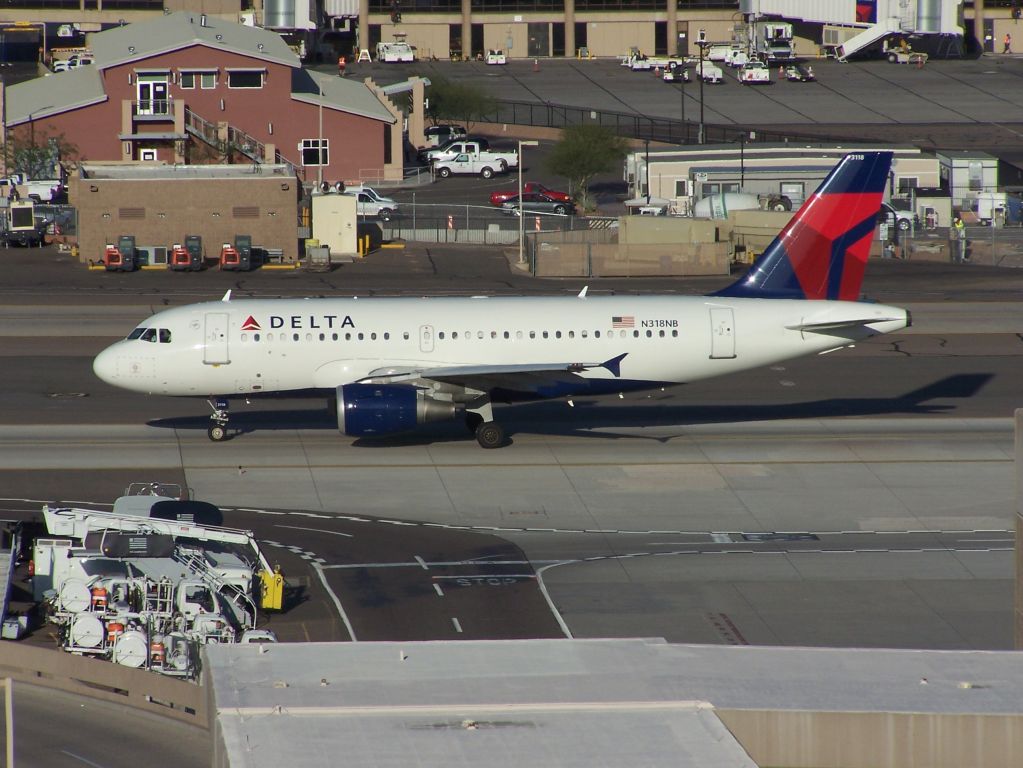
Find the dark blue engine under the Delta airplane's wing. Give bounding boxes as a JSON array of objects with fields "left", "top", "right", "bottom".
[{"left": 338, "top": 385, "right": 456, "bottom": 438}]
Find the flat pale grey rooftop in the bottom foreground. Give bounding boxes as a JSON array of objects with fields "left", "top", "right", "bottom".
[{"left": 203, "top": 639, "right": 1023, "bottom": 768}]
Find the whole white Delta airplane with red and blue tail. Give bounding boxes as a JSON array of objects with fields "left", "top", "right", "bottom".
[{"left": 93, "top": 151, "right": 910, "bottom": 448}]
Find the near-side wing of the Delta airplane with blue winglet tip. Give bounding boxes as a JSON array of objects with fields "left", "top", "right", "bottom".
[{"left": 367, "top": 353, "right": 628, "bottom": 393}]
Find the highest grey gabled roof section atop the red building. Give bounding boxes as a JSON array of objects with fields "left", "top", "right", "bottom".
[{"left": 89, "top": 11, "right": 301, "bottom": 69}]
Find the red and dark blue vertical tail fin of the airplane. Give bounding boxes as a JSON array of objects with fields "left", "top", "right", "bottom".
[{"left": 716, "top": 152, "right": 892, "bottom": 301}]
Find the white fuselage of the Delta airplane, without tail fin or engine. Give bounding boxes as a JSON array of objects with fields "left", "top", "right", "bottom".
[{"left": 93, "top": 296, "right": 908, "bottom": 397}]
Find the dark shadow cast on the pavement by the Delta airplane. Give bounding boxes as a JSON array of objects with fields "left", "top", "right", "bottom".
[{"left": 147, "top": 373, "right": 994, "bottom": 448}]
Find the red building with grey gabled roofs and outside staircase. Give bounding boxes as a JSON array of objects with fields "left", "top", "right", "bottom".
[{"left": 4, "top": 11, "right": 402, "bottom": 183}]
